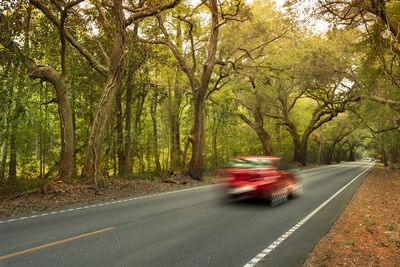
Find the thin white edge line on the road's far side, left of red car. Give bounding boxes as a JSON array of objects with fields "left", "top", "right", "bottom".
[{"left": 0, "top": 184, "right": 215, "bottom": 224}]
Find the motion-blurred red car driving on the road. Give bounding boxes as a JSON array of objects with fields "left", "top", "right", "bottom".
[{"left": 222, "top": 156, "right": 302, "bottom": 206}]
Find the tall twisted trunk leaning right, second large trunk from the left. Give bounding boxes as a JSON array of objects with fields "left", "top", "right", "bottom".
[{"left": 82, "top": 0, "right": 125, "bottom": 186}]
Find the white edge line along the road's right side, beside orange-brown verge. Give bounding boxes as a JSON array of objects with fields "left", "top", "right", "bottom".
[{"left": 243, "top": 164, "right": 375, "bottom": 267}]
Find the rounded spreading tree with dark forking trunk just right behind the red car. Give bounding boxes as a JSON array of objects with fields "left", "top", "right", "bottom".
[{"left": 231, "top": 29, "right": 359, "bottom": 165}]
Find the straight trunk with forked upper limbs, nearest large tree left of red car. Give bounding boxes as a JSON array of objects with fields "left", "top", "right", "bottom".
[{"left": 143, "top": 0, "right": 231, "bottom": 180}]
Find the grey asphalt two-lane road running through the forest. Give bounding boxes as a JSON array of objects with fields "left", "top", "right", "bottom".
[{"left": 0, "top": 162, "right": 374, "bottom": 267}]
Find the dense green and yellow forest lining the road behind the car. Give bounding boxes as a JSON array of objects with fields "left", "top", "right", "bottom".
[{"left": 0, "top": 0, "right": 400, "bottom": 191}]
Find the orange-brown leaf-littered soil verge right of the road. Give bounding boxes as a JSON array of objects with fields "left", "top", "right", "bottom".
[{"left": 303, "top": 164, "right": 400, "bottom": 267}]
